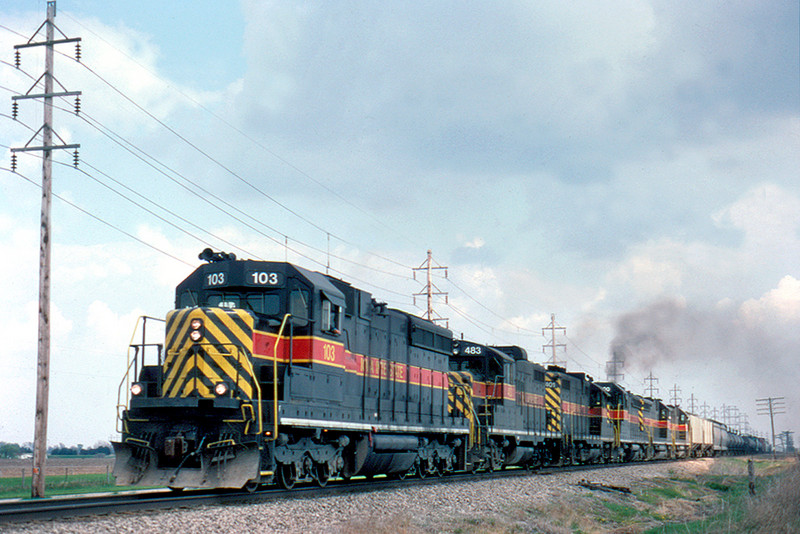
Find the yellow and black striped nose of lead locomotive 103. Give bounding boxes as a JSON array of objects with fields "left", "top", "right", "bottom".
[{"left": 162, "top": 308, "right": 255, "bottom": 400}]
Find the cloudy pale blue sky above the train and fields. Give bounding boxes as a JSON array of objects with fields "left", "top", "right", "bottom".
[{"left": 0, "top": 0, "right": 800, "bottom": 446}]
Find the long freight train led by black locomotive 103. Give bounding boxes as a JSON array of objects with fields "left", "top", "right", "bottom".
[{"left": 113, "top": 253, "right": 768, "bottom": 491}]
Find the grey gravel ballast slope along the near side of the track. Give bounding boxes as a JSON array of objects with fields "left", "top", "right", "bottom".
[{"left": 4, "top": 459, "right": 714, "bottom": 534}]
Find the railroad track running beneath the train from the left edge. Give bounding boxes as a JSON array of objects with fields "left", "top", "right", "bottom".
[{"left": 0, "top": 460, "right": 700, "bottom": 530}]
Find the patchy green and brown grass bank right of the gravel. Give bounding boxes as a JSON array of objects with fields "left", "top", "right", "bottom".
[{"left": 446, "top": 458, "right": 800, "bottom": 534}]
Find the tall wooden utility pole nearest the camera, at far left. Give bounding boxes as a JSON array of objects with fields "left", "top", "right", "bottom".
[{"left": 11, "top": 1, "right": 81, "bottom": 497}]
